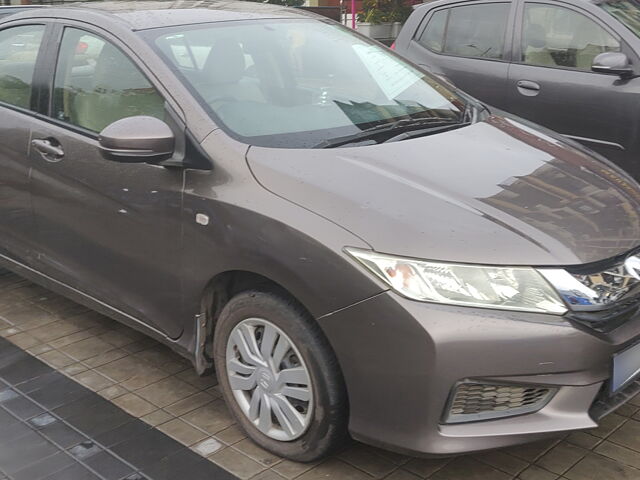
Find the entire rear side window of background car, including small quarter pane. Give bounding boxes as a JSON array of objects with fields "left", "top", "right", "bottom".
[{"left": 418, "top": 3, "right": 510, "bottom": 60}]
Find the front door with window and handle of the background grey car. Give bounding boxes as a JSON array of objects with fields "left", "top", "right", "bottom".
[{"left": 507, "top": 2, "right": 640, "bottom": 174}]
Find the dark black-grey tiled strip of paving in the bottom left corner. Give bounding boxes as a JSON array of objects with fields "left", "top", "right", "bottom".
[{"left": 0, "top": 338, "right": 235, "bottom": 480}]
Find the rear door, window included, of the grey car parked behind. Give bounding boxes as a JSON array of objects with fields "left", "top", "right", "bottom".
[{"left": 406, "top": 2, "right": 511, "bottom": 108}]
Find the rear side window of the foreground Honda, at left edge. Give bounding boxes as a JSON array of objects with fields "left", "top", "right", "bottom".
[{"left": 0, "top": 25, "right": 44, "bottom": 108}]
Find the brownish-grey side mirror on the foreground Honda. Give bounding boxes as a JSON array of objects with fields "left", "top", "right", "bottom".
[{"left": 98, "top": 116, "right": 175, "bottom": 163}]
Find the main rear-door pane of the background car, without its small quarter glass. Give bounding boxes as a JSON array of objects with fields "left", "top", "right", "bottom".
[{"left": 443, "top": 3, "right": 510, "bottom": 59}]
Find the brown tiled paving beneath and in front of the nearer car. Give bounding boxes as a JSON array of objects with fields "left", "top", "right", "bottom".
[{"left": 0, "top": 274, "right": 640, "bottom": 480}]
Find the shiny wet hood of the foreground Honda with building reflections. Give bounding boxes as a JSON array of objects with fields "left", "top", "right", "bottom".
[{"left": 247, "top": 116, "right": 640, "bottom": 266}]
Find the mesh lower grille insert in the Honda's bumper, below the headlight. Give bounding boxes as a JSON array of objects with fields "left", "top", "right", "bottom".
[{"left": 445, "top": 382, "right": 556, "bottom": 423}]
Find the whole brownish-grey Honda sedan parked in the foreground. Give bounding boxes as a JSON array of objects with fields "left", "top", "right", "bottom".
[{"left": 0, "top": 1, "right": 640, "bottom": 461}]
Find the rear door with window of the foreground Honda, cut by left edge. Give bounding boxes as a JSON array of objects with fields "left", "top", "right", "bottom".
[{"left": 0, "top": 25, "right": 45, "bottom": 265}]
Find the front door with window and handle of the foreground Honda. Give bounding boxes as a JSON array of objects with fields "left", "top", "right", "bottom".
[{"left": 30, "top": 28, "right": 183, "bottom": 338}]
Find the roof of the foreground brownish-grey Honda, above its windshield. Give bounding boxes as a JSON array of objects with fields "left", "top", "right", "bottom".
[{"left": 8, "top": 0, "right": 322, "bottom": 30}]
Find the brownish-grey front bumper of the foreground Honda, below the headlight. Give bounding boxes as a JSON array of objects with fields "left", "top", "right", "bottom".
[{"left": 319, "top": 292, "right": 640, "bottom": 455}]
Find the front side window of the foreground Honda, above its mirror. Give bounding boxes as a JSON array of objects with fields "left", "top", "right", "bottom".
[{"left": 53, "top": 28, "right": 164, "bottom": 132}]
